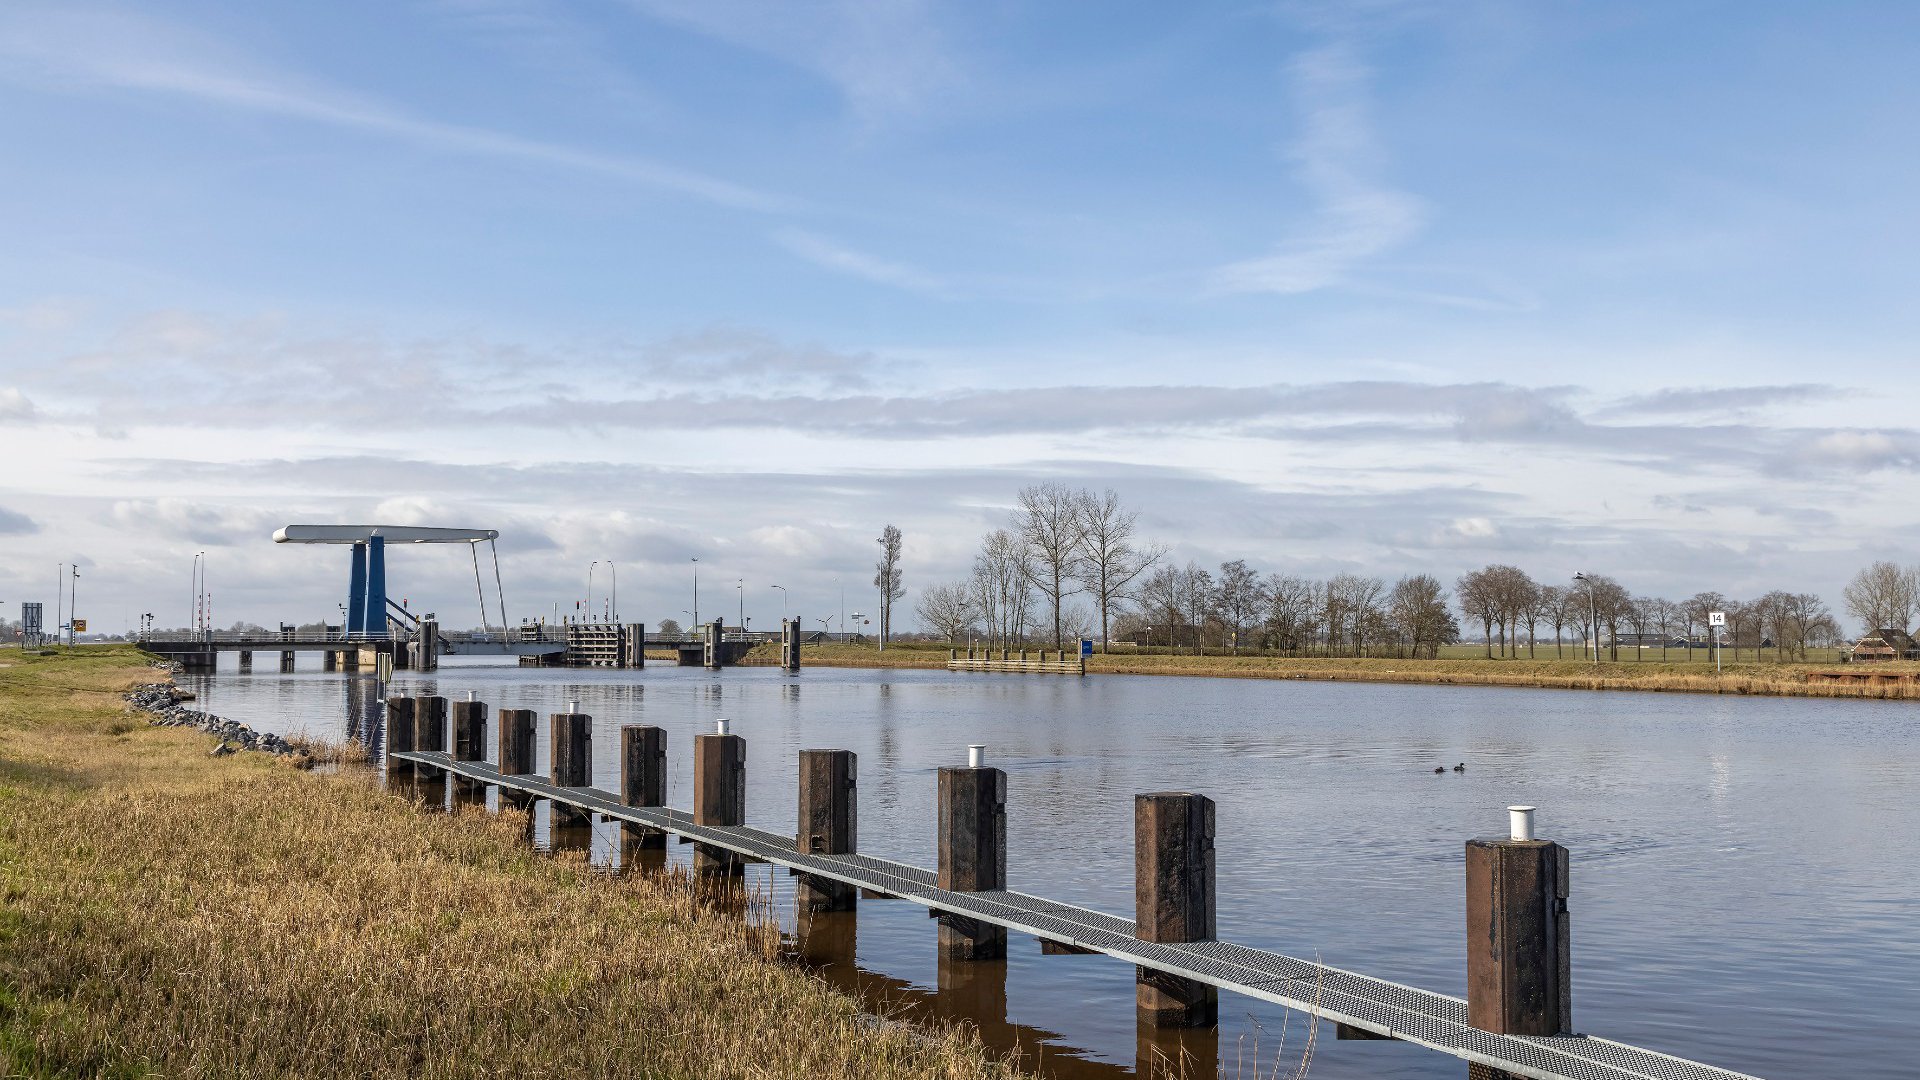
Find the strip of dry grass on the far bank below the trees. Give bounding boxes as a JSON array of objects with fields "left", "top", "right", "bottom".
[{"left": 756, "top": 642, "right": 1920, "bottom": 700}]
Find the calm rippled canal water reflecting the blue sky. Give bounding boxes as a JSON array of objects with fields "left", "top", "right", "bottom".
[{"left": 183, "top": 661, "right": 1920, "bottom": 1080}]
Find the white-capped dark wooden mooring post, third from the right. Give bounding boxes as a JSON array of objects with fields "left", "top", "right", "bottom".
[{"left": 937, "top": 744, "right": 1006, "bottom": 961}]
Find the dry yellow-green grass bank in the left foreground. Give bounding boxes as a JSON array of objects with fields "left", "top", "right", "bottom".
[{"left": 0, "top": 648, "right": 1004, "bottom": 1080}]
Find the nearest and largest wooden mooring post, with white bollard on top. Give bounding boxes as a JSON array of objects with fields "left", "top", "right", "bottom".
[{"left": 1467, "top": 807, "right": 1572, "bottom": 1080}]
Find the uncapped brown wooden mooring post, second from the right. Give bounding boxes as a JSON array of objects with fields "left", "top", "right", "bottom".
[{"left": 1133, "top": 792, "right": 1219, "bottom": 1028}]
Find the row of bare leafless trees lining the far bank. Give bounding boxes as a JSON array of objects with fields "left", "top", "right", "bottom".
[{"left": 913, "top": 484, "right": 1873, "bottom": 659}]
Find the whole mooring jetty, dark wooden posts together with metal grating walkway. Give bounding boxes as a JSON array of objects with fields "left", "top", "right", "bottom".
[{"left": 386, "top": 696, "right": 1755, "bottom": 1080}]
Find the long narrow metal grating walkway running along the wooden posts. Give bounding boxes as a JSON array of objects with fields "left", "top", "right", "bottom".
[{"left": 392, "top": 753, "right": 1757, "bottom": 1080}]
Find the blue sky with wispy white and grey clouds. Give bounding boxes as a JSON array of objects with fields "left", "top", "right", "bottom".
[{"left": 0, "top": 0, "right": 1920, "bottom": 630}]
